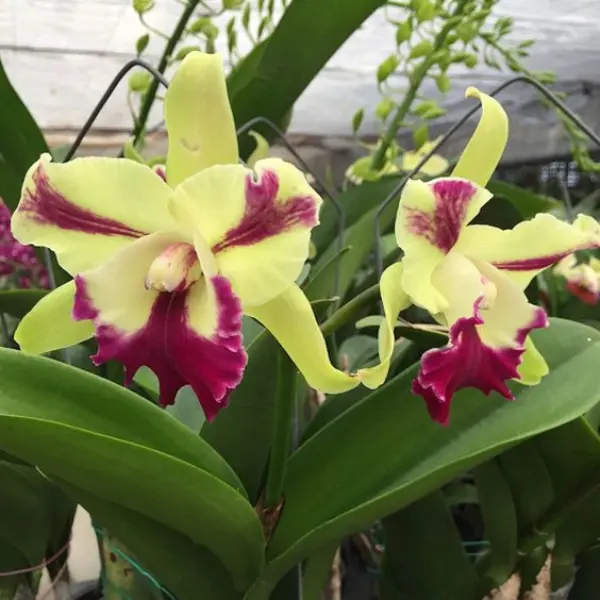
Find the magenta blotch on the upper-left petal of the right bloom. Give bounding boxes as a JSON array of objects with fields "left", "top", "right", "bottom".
[{"left": 405, "top": 179, "right": 477, "bottom": 253}]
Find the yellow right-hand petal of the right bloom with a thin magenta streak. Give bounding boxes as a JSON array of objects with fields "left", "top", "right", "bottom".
[{"left": 456, "top": 213, "right": 600, "bottom": 289}]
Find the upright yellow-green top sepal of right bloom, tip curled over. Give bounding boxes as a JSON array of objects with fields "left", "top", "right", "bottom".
[{"left": 452, "top": 87, "right": 508, "bottom": 187}]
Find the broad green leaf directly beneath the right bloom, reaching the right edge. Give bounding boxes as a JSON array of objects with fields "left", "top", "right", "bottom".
[{"left": 250, "top": 320, "right": 600, "bottom": 597}]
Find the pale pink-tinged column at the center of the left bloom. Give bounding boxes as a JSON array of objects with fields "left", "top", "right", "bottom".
[{"left": 146, "top": 243, "right": 202, "bottom": 292}]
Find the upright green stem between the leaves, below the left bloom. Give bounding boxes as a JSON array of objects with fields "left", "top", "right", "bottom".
[{"left": 264, "top": 349, "right": 296, "bottom": 507}]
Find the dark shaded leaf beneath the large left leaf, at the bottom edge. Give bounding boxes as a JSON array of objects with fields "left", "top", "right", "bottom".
[{"left": 56, "top": 479, "right": 241, "bottom": 600}]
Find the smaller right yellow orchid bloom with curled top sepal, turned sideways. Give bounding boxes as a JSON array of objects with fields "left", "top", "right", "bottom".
[{"left": 365, "top": 88, "right": 600, "bottom": 423}]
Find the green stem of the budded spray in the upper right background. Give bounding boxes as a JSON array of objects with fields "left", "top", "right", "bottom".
[{"left": 371, "top": 0, "right": 466, "bottom": 171}]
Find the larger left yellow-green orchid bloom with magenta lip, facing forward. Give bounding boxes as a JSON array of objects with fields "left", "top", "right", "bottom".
[{"left": 12, "top": 52, "right": 358, "bottom": 420}]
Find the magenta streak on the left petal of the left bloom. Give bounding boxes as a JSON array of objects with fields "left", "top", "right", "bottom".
[{"left": 19, "top": 165, "right": 148, "bottom": 238}]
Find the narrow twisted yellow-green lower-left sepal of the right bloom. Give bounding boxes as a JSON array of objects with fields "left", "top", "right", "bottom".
[{"left": 358, "top": 263, "right": 410, "bottom": 389}]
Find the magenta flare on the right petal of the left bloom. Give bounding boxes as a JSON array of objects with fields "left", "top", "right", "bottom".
[{"left": 212, "top": 171, "right": 317, "bottom": 253}]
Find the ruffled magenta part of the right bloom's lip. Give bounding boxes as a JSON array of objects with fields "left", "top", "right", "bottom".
[{"left": 412, "top": 297, "right": 548, "bottom": 425}]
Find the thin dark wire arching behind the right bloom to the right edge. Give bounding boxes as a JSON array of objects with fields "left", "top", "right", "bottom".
[{"left": 374, "top": 75, "right": 600, "bottom": 277}]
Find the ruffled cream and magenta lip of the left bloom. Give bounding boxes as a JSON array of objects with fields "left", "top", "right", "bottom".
[{"left": 73, "top": 233, "right": 246, "bottom": 420}]
